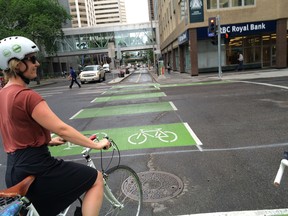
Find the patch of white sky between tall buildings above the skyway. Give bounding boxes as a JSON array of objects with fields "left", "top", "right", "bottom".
[{"left": 125, "top": 0, "right": 149, "bottom": 23}]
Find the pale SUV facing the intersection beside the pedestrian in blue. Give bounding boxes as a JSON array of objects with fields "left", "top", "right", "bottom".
[{"left": 79, "top": 65, "right": 105, "bottom": 84}]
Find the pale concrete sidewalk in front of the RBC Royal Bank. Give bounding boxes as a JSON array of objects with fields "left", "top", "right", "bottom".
[{"left": 149, "top": 68, "right": 288, "bottom": 84}]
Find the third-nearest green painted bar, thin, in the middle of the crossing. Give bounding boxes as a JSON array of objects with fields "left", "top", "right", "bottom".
[{"left": 92, "top": 92, "right": 166, "bottom": 103}]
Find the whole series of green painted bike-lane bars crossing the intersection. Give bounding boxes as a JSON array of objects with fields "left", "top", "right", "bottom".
[{"left": 51, "top": 82, "right": 228, "bottom": 156}]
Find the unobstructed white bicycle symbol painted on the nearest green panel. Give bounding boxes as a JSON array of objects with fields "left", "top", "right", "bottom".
[{"left": 128, "top": 128, "right": 178, "bottom": 145}]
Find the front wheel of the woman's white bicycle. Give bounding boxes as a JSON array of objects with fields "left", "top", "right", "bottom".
[{"left": 100, "top": 165, "right": 143, "bottom": 216}]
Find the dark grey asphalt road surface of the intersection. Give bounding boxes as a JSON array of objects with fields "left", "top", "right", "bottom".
[{"left": 0, "top": 71, "right": 288, "bottom": 216}]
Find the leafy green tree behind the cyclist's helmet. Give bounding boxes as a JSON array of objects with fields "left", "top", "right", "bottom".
[{"left": 0, "top": 0, "right": 70, "bottom": 54}]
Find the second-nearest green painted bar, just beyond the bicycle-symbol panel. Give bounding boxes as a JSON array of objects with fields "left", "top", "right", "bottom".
[{"left": 73, "top": 102, "right": 173, "bottom": 119}]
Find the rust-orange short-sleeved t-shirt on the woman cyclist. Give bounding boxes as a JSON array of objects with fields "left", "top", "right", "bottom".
[{"left": 0, "top": 85, "right": 51, "bottom": 153}]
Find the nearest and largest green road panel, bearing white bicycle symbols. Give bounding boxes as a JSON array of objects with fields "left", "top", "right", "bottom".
[{"left": 50, "top": 123, "right": 199, "bottom": 156}]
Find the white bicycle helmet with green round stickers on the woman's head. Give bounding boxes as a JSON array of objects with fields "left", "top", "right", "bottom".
[{"left": 0, "top": 36, "right": 39, "bottom": 70}]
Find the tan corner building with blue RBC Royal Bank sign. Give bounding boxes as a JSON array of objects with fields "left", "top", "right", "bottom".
[{"left": 158, "top": 0, "right": 288, "bottom": 76}]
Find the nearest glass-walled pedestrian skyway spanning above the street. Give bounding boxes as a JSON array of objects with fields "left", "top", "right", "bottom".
[{"left": 55, "top": 21, "right": 159, "bottom": 57}]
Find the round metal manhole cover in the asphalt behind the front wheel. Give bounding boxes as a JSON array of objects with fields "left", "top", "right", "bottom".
[{"left": 122, "top": 171, "right": 183, "bottom": 202}]
